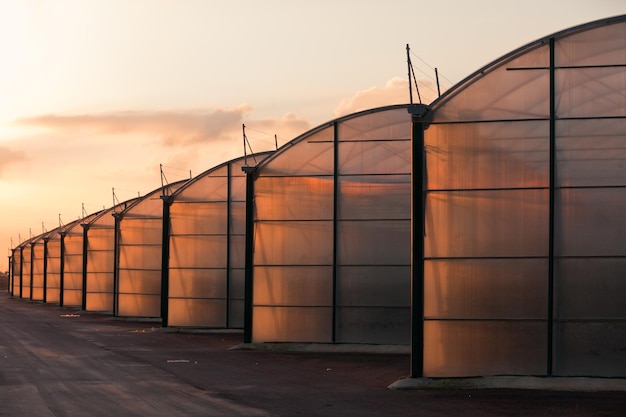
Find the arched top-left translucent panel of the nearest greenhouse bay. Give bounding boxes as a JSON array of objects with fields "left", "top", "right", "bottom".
[{"left": 434, "top": 44, "right": 550, "bottom": 122}]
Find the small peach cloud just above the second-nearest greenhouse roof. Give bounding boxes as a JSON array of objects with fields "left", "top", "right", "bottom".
[{"left": 335, "top": 77, "right": 437, "bottom": 117}]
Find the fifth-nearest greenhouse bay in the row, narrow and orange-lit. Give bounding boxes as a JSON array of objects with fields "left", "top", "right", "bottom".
[{"left": 82, "top": 199, "right": 136, "bottom": 313}]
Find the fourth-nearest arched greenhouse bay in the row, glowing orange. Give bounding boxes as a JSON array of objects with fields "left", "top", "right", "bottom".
[{"left": 114, "top": 180, "right": 187, "bottom": 318}]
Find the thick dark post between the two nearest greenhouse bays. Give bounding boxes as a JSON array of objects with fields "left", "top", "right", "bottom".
[{"left": 409, "top": 106, "right": 426, "bottom": 378}]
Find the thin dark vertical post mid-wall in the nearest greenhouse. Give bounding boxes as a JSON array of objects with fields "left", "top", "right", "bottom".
[{"left": 546, "top": 38, "right": 556, "bottom": 376}]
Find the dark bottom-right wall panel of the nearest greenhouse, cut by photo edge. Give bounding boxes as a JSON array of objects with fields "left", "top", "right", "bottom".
[{"left": 554, "top": 321, "right": 626, "bottom": 378}]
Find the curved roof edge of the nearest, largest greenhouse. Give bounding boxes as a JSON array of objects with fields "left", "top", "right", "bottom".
[{"left": 429, "top": 15, "right": 626, "bottom": 109}]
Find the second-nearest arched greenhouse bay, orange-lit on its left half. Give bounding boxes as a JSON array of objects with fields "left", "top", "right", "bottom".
[{"left": 245, "top": 106, "right": 411, "bottom": 344}]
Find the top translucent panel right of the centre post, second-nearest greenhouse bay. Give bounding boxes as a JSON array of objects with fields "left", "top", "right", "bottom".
[{"left": 338, "top": 107, "right": 411, "bottom": 141}]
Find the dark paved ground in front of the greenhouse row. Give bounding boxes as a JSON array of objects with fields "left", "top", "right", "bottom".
[{"left": 0, "top": 292, "right": 626, "bottom": 417}]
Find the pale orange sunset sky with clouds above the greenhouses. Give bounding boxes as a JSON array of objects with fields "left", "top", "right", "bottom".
[{"left": 0, "top": 0, "right": 626, "bottom": 271}]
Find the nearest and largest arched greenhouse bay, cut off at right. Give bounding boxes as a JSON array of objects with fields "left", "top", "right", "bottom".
[{"left": 412, "top": 16, "right": 626, "bottom": 377}]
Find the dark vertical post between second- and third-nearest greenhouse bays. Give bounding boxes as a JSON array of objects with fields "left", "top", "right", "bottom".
[{"left": 242, "top": 166, "right": 256, "bottom": 343}]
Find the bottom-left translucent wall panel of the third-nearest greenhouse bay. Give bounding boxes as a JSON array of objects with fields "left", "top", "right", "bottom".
[{"left": 168, "top": 298, "right": 227, "bottom": 328}]
